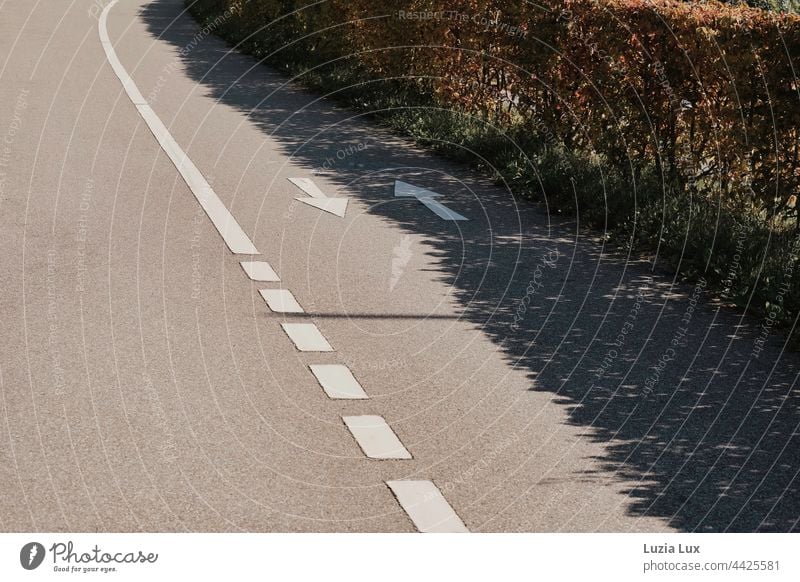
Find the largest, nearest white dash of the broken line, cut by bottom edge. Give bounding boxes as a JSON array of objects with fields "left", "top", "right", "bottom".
[{"left": 386, "top": 481, "right": 469, "bottom": 533}]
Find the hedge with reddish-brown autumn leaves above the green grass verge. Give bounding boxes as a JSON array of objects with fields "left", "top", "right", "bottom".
[{"left": 194, "top": 0, "right": 800, "bottom": 215}]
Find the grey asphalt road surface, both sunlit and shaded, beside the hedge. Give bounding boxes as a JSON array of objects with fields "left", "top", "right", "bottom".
[{"left": 0, "top": 0, "right": 800, "bottom": 532}]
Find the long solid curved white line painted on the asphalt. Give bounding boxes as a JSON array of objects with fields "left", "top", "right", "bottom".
[{"left": 97, "top": 0, "right": 259, "bottom": 255}]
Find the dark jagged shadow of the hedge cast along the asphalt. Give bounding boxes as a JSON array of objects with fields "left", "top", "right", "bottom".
[{"left": 141, "top": 0, "right": 800, "bottom": 532}]
